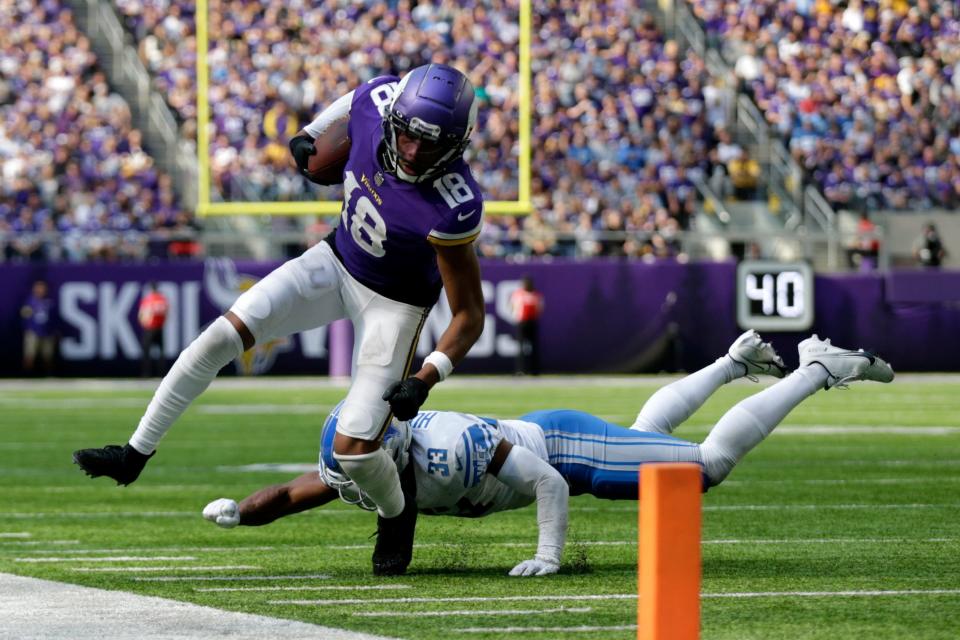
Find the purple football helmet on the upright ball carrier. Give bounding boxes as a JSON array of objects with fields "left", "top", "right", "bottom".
[{"left": 383, "top": 64, "right": 477, "bottom": 182}]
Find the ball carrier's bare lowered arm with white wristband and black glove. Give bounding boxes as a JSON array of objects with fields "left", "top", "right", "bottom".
[{"left": 383, "top": 242, "right": 484, "bottom": 420}]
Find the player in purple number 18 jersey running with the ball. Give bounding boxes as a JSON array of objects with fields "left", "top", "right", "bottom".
[{"left": 74, "top": 64, "right": 484, "bottom": 575}]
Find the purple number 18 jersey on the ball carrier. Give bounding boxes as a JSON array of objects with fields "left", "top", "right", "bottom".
[{"left": 330, "top": 76, "right": 483, "bottom": 307}]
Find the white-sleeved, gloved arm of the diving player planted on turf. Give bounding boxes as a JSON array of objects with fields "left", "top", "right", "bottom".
[{"left": 488, "top": 440, "right": 570, "bottom": 576}]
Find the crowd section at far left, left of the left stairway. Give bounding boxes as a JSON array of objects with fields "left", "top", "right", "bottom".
[{"left": 0, "top": 0, "right": 195, "bottom": 261}]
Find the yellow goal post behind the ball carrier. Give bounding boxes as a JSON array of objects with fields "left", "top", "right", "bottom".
[{"left": 195, "top": 0, "right": 533, "bottom": 216}]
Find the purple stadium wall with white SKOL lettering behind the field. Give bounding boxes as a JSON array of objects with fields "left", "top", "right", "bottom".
[{"left": 0, "top": 259, "right": 960, "bottom": 376}]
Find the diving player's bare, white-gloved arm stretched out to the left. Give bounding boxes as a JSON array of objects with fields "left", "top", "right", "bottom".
[{"left": 203, "top": 471, "right": 337, "bottom": 529}]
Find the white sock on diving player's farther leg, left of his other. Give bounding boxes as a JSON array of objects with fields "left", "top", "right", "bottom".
[{"left": 630, "top": 356, "right": 746, "bottom": 433}]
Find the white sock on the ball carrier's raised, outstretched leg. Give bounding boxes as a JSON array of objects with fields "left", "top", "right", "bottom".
[{"left": 130, "top": 316, "right": 243, "bottom": 454}]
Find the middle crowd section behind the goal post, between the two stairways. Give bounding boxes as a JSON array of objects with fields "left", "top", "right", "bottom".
[{"left": 115, "top": 0, "right": 737, "bottom": 256}]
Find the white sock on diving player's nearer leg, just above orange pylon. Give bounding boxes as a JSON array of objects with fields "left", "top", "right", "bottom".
[{"left": 700, "top": 366, "right": 827, "bottom": 486}]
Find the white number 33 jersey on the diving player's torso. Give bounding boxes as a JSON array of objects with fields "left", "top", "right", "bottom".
[{"left": 409, "top": 411, "right": 547, "bottom": 517}]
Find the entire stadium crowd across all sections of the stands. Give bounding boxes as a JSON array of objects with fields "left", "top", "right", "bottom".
[{"left": 0, "top": 0, "right": 960, "bottom": 259}]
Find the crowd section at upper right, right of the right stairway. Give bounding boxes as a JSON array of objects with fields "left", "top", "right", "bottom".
[{"left": 690, "top": 0, "right": 960, "bottom": 211}]
